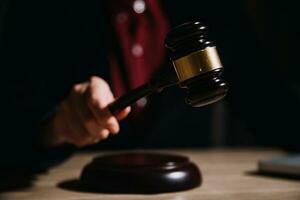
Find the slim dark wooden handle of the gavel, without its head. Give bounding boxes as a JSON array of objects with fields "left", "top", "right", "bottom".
[{"left": 108, "top": 75, "right": 178, "bottom": 115}]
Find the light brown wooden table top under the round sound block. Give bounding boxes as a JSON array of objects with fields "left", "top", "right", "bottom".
[{"left": 0, "top": 149, "right": 300, "bottom": 200}]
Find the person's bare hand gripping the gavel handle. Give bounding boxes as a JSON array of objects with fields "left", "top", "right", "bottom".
[{"left": 43, "top": 76, "right": 130, "bottom": 147}]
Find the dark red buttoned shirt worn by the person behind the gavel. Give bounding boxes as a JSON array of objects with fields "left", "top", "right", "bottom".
[{"left": 109, "top": 0, "right": 168, "bottom": 97}]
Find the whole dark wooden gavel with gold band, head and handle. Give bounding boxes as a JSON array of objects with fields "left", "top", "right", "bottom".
[{"left": 109, "top": 22, "right": 228, "bottom": 114}]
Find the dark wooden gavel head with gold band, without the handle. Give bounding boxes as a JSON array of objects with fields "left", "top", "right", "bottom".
[{"left": 165, "top": 22, "right": 228, "bottom": 107}]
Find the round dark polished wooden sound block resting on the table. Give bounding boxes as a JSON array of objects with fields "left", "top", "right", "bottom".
[{"left": 80, "top": 153, "right": 202, "bottom": 193}]
